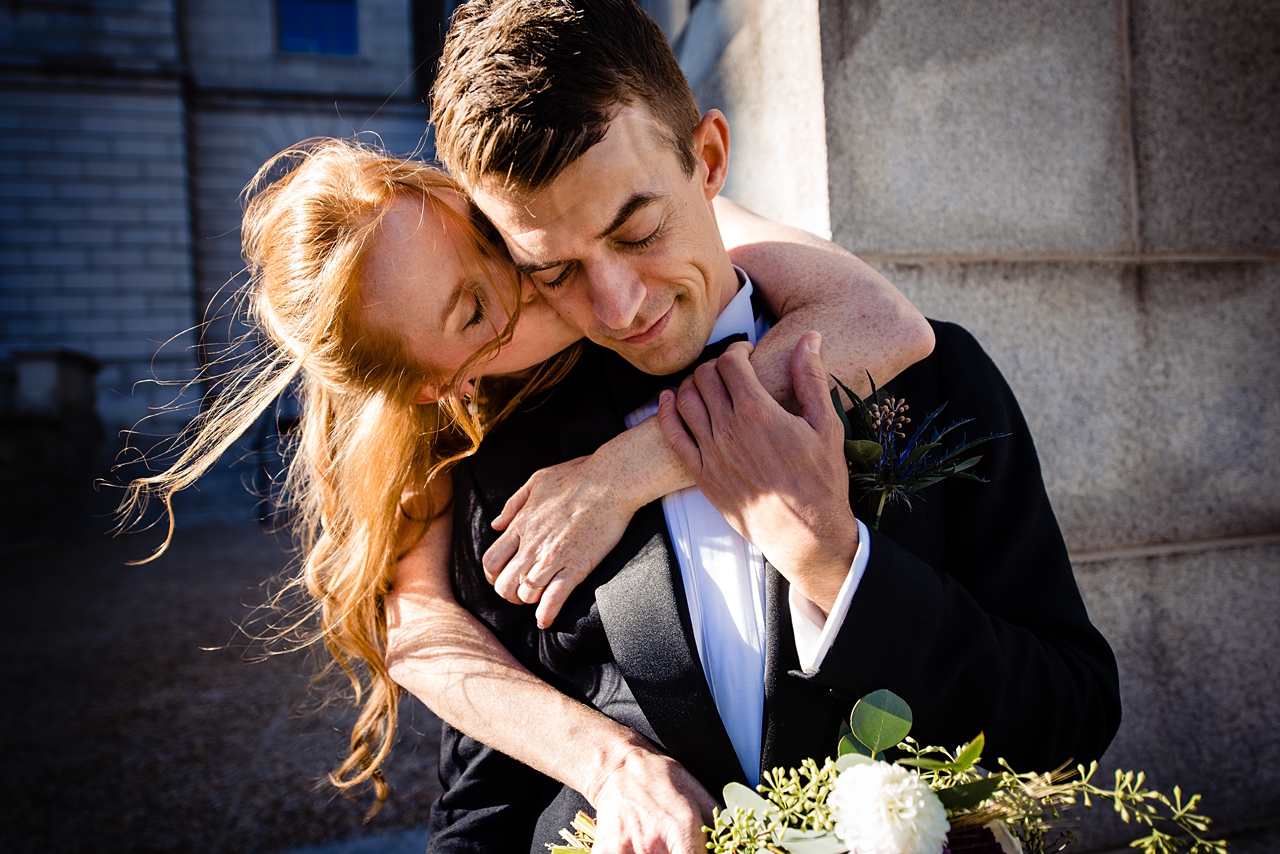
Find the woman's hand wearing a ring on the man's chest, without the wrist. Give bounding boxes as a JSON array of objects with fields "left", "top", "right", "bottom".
[{"left": 483, "top": 456, "right": 643, "bottom": 629}]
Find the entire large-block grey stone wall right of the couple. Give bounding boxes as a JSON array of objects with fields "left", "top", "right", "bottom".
[{"left": 704, "top": 0, "right": 1280, "bottom": 851}]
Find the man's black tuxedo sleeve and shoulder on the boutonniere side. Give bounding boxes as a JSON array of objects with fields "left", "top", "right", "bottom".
[{"left": 812, "top": 324, "right": 1120, "bottom": 771}]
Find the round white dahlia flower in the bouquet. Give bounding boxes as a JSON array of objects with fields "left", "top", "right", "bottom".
[{"left": 828, "top": 762, "right": 951, "bottom": 854}]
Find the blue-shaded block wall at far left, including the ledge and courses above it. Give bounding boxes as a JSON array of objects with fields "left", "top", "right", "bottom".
[{"left": 0, "top": 10, "right": 197, "bottom": 445}]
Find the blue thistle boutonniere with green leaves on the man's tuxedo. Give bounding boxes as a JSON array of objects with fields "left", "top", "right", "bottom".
[{"left": 831, "top": 374, "right": 1009, "bottom": 529}]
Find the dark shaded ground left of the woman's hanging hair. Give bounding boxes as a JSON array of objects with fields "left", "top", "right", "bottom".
[{"left": 0, "top": 526, "right": 439, "bottom": 854}]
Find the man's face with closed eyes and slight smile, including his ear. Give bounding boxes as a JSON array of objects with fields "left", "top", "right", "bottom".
[{"left": 472, "top": 106, "right": 737, "bottom": 374}]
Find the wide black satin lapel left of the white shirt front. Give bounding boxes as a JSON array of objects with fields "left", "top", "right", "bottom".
[{"left": 595, "top": 502, "right": 746, "bottom": 793}]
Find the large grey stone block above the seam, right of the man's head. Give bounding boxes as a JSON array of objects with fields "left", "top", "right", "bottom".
[{"left": 819, "top": 0, "right": 1133, "bottom": 254}]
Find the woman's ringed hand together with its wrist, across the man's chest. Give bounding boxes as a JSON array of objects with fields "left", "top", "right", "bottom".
[{"left": 483, "top": 419, "right": 694, "bottom": 629}]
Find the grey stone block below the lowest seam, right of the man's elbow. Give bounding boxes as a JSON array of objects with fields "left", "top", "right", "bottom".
[{"left": 1076, "top": 536, "right": 1280, "bottom": 851}]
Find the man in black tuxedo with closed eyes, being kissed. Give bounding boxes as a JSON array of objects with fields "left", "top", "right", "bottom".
[{"left": 414, "top": 0, "right": 1120, "bottom": 851}]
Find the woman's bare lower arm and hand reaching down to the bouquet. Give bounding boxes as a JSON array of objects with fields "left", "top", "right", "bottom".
[{"left": 385, "top": 478, "right": 714, "bottom": 850}]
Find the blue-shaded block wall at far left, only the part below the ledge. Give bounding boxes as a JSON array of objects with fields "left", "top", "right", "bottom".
[{"left": 0, "top": 77, "right": 197, "bottom": 437}]
